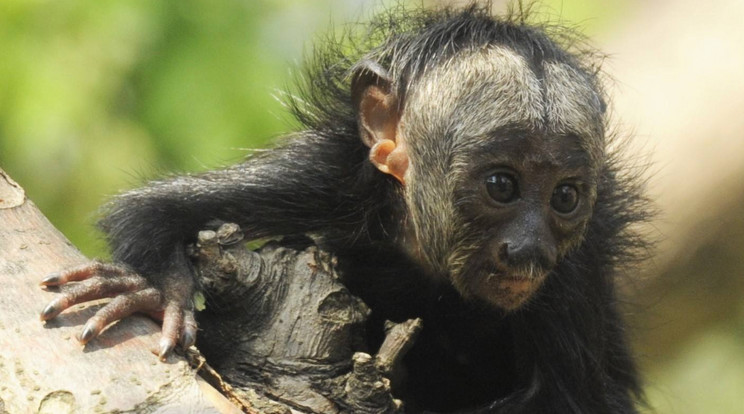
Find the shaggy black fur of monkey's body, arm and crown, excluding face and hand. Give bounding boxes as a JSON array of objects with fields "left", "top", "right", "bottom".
[{"left": 101, "top": 6, "right": 647, "bottom": 414}]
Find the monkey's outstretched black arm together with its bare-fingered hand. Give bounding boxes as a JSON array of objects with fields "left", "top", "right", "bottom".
[{"left": 41, "top": 136, "right": 364, "bottom": 358}]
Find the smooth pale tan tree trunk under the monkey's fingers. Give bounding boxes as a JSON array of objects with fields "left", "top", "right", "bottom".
[{"left": 0, "top": 169, "right": 240, "bottom": 414}]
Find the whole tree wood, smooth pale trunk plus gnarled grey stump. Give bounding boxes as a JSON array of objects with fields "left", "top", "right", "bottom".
[{"left": 0, "top": 170, "right": 422, "bottom": 414}]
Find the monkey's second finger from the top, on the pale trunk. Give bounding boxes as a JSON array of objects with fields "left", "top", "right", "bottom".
[{"left": 40, "top": 274, "right": 148, "bottom": 321}]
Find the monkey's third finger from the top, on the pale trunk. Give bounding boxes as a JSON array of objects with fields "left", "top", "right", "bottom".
[{"left": 78, "top": 288, "right": 162, "bottom": 344}]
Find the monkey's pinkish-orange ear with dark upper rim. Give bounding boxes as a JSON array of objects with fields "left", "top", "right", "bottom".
[{"left": 351, "top": 61, "right": 408, "bottom": 184}]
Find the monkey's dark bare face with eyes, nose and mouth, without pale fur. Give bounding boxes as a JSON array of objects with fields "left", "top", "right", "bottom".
[{"left": 442, "top": 130, "right": 597, "bottom": 310}]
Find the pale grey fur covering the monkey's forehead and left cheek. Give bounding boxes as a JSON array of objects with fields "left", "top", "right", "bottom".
[{"left": 390, "top": 46, "right": 602, "bottom": 278}]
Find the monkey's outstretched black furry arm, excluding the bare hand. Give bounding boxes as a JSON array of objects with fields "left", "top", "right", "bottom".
[{"left": 100, "top": 136, "right": 366, "bottom": 264}]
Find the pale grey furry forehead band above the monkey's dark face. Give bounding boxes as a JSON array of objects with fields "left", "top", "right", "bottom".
[{"left": 401, "top": 46, "right": 603, "bottom": 151}]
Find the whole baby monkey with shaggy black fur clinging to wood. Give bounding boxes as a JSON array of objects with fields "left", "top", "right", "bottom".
[{"left": 41, "top": 5, "right": 647, "bottom": 414}]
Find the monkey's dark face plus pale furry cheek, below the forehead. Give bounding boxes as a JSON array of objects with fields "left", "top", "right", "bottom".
[{"left": 396, "top": 128, "right": 597, "bottom": 311}]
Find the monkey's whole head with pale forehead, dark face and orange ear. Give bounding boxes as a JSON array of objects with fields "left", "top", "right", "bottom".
[{"left": 352, "top": 45, "right": 604, "bottom": 311}]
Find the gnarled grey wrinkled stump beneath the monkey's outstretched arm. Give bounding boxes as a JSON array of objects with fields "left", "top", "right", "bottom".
[{"left": 192, "top": 224, "right": 421, "bottom": 414}]
